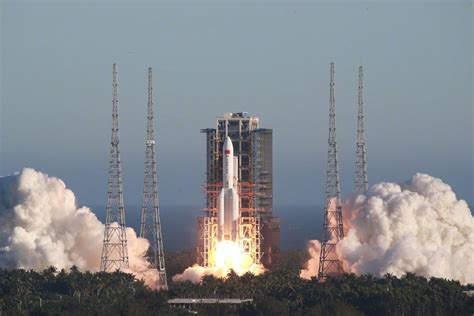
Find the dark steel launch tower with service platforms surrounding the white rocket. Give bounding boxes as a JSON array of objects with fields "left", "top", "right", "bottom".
[{"left": 197, "top": 112, "right": 280, "bottom": 268}]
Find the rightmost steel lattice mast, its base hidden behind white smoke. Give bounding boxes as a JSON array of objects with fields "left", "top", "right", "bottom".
[{"left": 354, "top": 66, "right": 369, "bottom": 194}]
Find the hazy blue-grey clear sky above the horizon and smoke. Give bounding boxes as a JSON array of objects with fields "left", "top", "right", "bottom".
[{"left": 0, "top": 0, "right": 474, "bottom": 205}]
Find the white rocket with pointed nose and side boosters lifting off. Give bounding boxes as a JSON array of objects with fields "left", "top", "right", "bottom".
[{"left": 217, "top": 136, "right": 240, "bottom": 241}]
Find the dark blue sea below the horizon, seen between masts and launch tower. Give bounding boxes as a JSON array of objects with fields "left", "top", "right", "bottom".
[{"left": 91, "top": 205, "right": 323, "bottom": 251}]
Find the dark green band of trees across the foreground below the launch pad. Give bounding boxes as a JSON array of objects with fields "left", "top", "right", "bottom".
[{"left": 0, "top": 252, "right": 474, "bottom": 316}]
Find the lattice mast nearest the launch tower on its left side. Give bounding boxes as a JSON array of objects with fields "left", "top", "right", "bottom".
[{"left": 140, "top": 67, "right": 168, "bottom": 289}]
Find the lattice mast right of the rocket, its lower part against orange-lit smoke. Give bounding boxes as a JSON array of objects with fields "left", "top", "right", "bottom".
[{"left": 318, "top": 63, "right": 344, "bottom": 281}]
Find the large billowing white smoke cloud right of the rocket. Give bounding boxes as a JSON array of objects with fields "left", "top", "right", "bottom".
[{"left": 302, "top": 173, "right": 474, "bottom": 283}]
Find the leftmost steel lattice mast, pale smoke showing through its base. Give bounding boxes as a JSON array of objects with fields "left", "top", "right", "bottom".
[{"left": 100, "top": 63, "right": 128, "bottom": 272}]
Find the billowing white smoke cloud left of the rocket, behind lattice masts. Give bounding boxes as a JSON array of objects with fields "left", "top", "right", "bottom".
[{"left": 0, "top": 169, "right": 158, "bottom": 288}]
